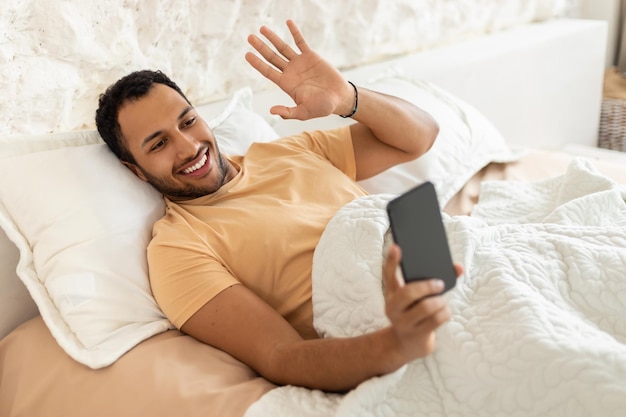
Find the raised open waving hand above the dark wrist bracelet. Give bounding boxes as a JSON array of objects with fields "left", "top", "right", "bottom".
[{"left": 246, "top": 20, "right": 354, "bottom": 120}]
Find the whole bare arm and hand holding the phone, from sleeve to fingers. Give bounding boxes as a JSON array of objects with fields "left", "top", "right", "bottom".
[{"left": 182, "top": 246, "right": 460, "bottom": 391}]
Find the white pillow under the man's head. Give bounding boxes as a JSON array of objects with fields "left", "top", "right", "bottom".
[{"left": 0, "top": 89, "right": 278, "bottom": 368}]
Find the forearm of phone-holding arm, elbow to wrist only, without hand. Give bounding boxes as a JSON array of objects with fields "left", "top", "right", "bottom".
[{"left": 262, "top": 328, "right": 407, "bottom": 392}]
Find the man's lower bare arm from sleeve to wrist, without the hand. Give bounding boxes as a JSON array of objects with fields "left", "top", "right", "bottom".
[{"left": 181, "top": 285, "right": 412, "bottom": 391}]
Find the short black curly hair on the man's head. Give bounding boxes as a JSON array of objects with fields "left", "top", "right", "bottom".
[{"left": 96, "top": 70, "right": 191, "bottom": 164}]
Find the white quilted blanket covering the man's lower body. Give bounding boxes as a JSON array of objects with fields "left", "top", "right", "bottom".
[{"left": 246, "top": 160, "right": 626, "bottom": 417}]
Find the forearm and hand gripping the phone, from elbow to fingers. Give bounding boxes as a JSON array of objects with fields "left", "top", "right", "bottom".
[{"left": 266, "top": 245, "right": 450, "bottom": 391}]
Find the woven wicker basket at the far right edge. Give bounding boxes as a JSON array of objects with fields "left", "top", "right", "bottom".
[{"left": 598, "top": 97, "right": 626, "bottom": 152}]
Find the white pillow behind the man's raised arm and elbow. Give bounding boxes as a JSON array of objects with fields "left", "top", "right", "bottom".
[{"left": 360, "top": 77, "right": 523, "bottom": 207}]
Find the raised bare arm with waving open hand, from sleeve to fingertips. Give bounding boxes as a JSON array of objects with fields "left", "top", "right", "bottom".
[{"left": 246, "top": 21, "right": 439, "bottom": 180}]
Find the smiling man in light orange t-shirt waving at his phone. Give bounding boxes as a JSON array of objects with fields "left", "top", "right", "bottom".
[{"left": 96, "top": 21, "right": 460, "bottom": 391}]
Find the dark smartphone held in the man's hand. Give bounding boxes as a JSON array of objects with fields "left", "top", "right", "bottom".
[{"left": 387, "top": 181, "right": 456, "bottom": 292}]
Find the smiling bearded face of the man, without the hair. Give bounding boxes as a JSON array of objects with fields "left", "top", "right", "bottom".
[{"left": 118, "top": 84, "right": 236, "bottom": 201}]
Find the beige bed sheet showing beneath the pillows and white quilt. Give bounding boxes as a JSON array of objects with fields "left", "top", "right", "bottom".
[{"left": 0, "top": 146, "right": 626, "bottom": 417}]
